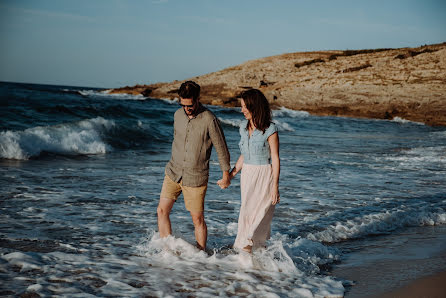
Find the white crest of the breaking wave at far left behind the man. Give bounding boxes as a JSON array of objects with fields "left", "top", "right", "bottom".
[{"left": 0, "top": 117, "right": 115, "bottom": 159}]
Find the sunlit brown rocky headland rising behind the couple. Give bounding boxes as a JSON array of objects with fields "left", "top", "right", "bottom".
[{"left": 110, "top": 43, "right": 446, "bottom": 126}]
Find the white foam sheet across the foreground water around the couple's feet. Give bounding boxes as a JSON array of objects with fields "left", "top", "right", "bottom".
[{"left": 0, "top": 231, "right": 344, "bottom": 297}]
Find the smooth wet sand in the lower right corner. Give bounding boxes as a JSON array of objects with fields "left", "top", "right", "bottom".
[{"left": 331, "top": 226, "right": 446, "bottom": 298}]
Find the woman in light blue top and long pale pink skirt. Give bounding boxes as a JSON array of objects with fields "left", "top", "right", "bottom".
[{"left": 229, "top": 89, "right": 280, "bottom": 253}]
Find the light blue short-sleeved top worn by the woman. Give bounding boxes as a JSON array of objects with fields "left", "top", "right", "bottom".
[{"left": 239, "top": 120, "right": 277, "bottom": 165}]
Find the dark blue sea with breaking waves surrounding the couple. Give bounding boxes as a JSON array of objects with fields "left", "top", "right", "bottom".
[{"left": 0, "top": 83, "right": 446, "bottom": 297}]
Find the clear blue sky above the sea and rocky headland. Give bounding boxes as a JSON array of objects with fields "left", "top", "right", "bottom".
[{"left": 0, "top": 0, "right": 446, "bottom": 88}]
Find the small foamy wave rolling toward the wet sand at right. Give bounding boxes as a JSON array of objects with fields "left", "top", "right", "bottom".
[{"left": 307, "top": 206, "right": 446, "bottom": 243}]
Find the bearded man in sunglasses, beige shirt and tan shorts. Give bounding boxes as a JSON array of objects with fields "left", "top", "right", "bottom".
[{"left": 157, "top": 81, "right": 230, "bottom": 250}]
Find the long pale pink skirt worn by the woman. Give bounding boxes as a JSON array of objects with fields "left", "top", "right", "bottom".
[{"left": 234, "top": 164, "right": 275, "bottom": 249}]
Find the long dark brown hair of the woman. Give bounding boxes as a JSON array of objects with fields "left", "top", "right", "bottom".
[{"left": 240, "top": 89, "right": 272, "bottom": 133}]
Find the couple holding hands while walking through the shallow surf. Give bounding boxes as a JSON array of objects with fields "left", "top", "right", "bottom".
[{"left": 157, "top": 81, "right": 280, "bottom": 253}]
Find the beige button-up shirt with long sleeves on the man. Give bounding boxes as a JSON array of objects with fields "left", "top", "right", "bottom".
[{"left": 166, "top": 104, "right": 230, "bottom": 187}]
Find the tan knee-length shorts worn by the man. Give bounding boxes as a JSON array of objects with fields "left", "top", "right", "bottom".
[{"left": 160, "top": 175, "right": 208, "bottom": 212}]
